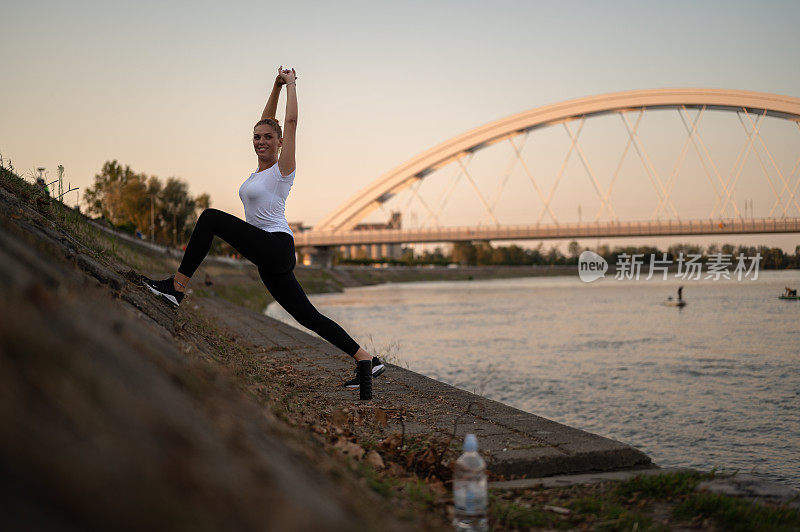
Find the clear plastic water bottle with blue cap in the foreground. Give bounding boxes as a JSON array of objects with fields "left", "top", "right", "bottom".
[{"left": 453, "top": 434, "right": 488, "bottom": 532}]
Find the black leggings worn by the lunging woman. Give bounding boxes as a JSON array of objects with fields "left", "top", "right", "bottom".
[{"left": 178, "top": 209, "right": 359, "bottom": 356}]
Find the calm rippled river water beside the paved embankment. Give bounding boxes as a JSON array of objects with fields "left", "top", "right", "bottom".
[{"left": 267, "top": 271, "right": 800, "bottom": 487}]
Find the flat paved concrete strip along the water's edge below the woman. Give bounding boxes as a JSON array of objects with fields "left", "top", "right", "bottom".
[{"left": 195, "top": 299, "right": 652, "bottom": 478}]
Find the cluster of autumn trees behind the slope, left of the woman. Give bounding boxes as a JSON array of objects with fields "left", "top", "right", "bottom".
[{"left": 83, "top": 160, "right": 211, "bottom": 246}]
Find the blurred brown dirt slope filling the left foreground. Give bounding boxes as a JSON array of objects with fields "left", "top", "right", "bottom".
[{"left": 0, "top": 169, "right": 435, "bottom": 530}]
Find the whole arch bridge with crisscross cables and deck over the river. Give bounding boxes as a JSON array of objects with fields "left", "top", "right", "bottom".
[{"left": 295, "top": 89, "right": 800, "bottom": 260}]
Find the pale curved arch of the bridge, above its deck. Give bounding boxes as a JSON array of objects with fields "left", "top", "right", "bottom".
[{"left": 310, "top": 88, "right": 800, "bottom": 235}]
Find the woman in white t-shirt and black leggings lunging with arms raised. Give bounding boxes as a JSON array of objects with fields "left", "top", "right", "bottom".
[{"left": 144, "top": 67, "right": 385, "bottom": 388}]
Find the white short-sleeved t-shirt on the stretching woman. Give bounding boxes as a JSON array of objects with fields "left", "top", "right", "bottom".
[{"left": 239, "top": 163, "right": 294, "bottom": 237}]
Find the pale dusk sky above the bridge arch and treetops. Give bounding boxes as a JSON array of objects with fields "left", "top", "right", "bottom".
[{"left": 0, "top": 0, "right": 800, "bottom": 249}]
